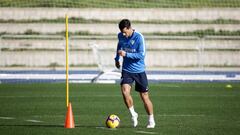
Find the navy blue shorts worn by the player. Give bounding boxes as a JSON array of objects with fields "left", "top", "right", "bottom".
[{"left": 121, "top": 70, "right": 148, "bottom": 92}]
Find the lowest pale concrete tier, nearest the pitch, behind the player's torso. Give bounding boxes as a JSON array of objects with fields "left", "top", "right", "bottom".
[{"left": 0, "top": 50, "right": 240, "bottom": 67}]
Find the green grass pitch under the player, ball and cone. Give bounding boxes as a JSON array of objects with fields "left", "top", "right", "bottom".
[{"left": 0, "top": 83, "right": 240, "bottom": 135}]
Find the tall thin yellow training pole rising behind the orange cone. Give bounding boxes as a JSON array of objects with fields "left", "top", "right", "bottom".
[{"left": 65, "top": 14, "right": 69, "bottom": 107}]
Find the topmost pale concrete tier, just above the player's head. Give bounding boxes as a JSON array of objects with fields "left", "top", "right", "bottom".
[{"left": 0, "top": 8, "right": 240, "bottom": 21}]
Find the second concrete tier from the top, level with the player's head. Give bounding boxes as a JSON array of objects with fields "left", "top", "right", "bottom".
[{"left": 0, "top": 23, "right": 240, "bottom": 35}]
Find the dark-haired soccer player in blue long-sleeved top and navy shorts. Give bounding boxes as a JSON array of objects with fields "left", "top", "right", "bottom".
[{"left": 115, "top": 19, "right": 155, "bottom": 128}]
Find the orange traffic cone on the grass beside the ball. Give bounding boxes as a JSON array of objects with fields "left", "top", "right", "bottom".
[{"left": 64, "top": 103, "right": 75, "bottom": 128}]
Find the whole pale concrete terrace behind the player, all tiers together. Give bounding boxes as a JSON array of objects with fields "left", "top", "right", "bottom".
[{"left": 0, "top": 8, "right": 240, "bottom": 68}]
